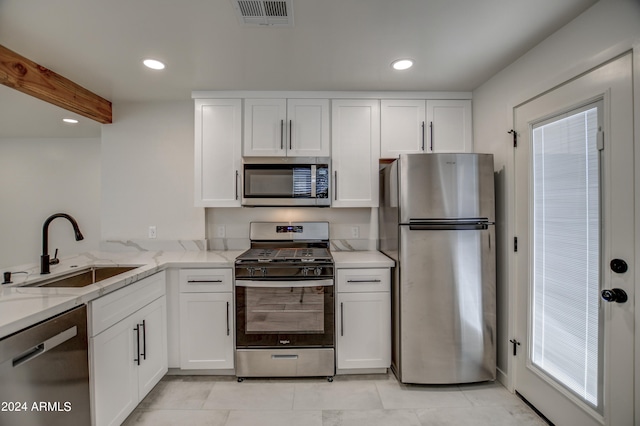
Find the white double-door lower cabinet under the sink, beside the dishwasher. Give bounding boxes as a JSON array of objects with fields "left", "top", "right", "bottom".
[{"left": 90, "top": 272, "right": 167, "bottom": 426}]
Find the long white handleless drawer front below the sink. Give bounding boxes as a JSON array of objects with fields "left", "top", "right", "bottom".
[{"left": 89, "top": 272, "right": 166, "bottom": 336}]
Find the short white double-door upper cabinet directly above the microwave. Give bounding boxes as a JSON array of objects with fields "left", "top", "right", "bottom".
[{"left": 243, "top": 99, "right": 330, "bottom": 157}]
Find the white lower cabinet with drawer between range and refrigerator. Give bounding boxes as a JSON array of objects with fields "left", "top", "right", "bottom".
[{"left": 336, "top": 268, "right": 391, "bottom": 373}]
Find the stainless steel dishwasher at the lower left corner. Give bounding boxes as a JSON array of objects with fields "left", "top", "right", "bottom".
[{"left": 0, "top": 306, "right": 91, "bottom": 426}]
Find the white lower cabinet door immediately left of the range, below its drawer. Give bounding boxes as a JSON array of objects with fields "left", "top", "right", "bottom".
[{"left": 180, "top": 293, "right": 234, "bottom": 370}]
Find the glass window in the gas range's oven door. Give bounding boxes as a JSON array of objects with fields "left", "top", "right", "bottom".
[{"left": 245, "top": 286, "right": 325, "bottom": 334}]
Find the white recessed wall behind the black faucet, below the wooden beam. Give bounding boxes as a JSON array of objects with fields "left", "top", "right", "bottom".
[{"left": 0, "top": 138, "right": 100, "bottom": 268}]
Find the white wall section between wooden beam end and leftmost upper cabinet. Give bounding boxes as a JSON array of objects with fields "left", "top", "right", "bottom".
[{"left": 101, "top": 100, "right": 205, "bottom": 240}]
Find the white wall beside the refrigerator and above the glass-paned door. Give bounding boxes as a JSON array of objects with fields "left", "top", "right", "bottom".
[{"left": 473, "top": 0, "right": 640, "bottom": 386}]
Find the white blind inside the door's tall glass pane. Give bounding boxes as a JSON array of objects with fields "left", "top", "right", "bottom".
[{"left": 530, "top": 105, "right": 601, "bottom": 407}]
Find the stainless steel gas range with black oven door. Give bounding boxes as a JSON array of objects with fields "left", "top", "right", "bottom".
[{"left": 235, "top": 222, "right": 335, "bottom": 381}]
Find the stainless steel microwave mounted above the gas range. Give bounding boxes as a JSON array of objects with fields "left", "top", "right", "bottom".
[{"left": 242, "top": 157, "right": 331, "bottom": 207}]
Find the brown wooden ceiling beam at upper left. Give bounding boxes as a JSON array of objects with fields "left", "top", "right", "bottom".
[{"left": 0, "top": 45, "right": 112, "bottom": 124}]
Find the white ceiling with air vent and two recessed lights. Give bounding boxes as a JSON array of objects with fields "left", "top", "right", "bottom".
[{"left": 0, "top": 0, "right": 595, "bottom": 136}]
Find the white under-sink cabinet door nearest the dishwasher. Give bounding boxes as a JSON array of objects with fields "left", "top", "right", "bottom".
[{"left": 91, "top": 317, "right": 138, "bottom": 426}]
